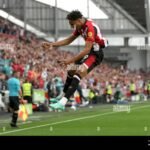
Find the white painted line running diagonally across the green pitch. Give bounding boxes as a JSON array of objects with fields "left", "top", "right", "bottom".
[{"left": 0, "top": 105, "right": 150, "bottom": 135}]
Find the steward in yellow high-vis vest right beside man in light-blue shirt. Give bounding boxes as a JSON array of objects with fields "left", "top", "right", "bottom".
[{"left": 22, "top": 79, "right": 32, "bottom": 103}]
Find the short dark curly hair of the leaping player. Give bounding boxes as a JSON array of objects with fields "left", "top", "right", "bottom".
[{"left": 66, "top": 10, "right": 83, "bottom": 21}]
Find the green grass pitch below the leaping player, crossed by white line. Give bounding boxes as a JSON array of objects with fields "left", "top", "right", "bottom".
[{"left": 0, "top": 101, "right": 150, "bottom": 136}]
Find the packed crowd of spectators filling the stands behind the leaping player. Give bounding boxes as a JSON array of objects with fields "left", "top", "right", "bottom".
[{"left": 0, "top": 18, "right": 150, "bottom": 111}]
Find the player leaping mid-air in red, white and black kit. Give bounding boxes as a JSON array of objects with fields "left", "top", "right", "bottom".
[{"left": 42, "top": 10, "right": 107, "bottom": 110}]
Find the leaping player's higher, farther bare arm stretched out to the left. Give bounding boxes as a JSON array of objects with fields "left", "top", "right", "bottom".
[{"left": 42, "top": 35, "right": 77, "bottom": 49}]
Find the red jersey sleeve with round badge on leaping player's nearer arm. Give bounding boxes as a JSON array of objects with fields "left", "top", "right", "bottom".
[{"left": 85, "top": 26, "right": 95, "bottom": 43}]
